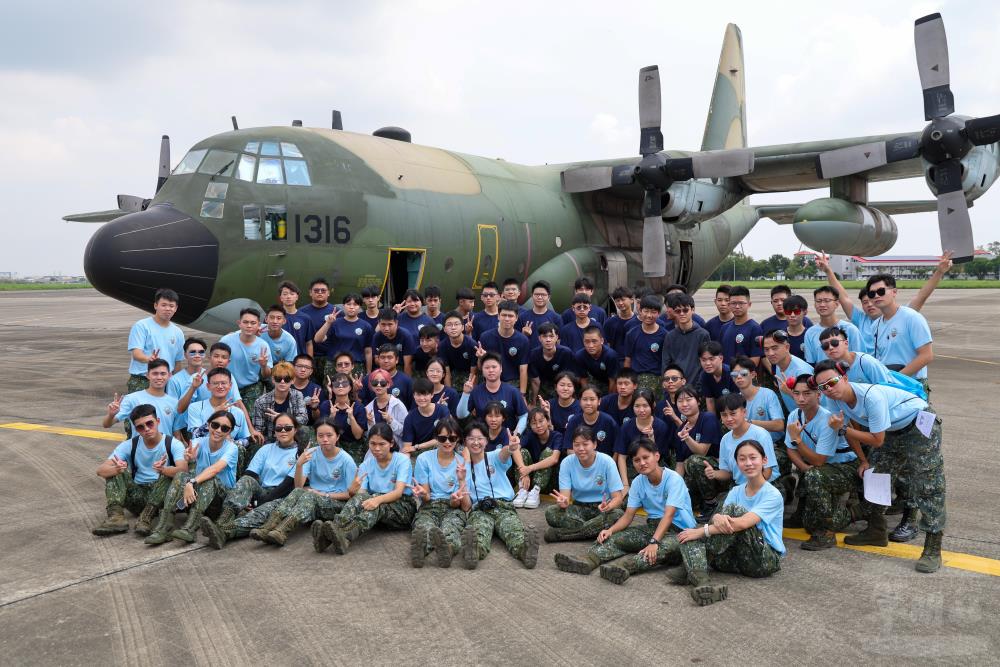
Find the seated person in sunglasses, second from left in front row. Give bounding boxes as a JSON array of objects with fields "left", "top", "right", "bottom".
[{"left": 145, "top": 410, "right": 240, "bottom": 545}]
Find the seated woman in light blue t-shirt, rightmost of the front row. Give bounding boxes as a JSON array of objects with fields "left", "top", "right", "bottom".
[{"left": 677, "top": 440, "right": 785, "bottom": 605}]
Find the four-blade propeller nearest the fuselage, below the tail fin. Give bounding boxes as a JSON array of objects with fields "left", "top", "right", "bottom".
[{"left": 562, "top": 65, "right": 753, "bottom": 278}]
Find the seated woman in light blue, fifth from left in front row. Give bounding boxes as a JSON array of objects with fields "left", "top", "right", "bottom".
[{"left": 322, "top": 422, "right": 417, "bottom": 554}]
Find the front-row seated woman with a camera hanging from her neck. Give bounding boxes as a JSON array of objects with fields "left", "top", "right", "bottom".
[{"left": 462, "top": 421, "right": 538, "bottom": 570}]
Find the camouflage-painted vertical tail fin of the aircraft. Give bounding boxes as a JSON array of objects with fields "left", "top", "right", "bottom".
[{"left": 701, "top": 23, "right": 747, "bottom": 151}]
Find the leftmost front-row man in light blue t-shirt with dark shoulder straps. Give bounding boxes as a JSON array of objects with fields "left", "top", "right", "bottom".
[{"left": 92, "top": 403, "right": 186, "bottom": 537}]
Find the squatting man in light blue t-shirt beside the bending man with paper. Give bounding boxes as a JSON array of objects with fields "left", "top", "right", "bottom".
[{"left": 785, "top": 373, "right": 860, "bottom": 551}]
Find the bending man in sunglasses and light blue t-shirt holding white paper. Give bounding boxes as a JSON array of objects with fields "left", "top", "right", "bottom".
[{"left": 814, "top": 359, "right": 945, "bottom": 572}]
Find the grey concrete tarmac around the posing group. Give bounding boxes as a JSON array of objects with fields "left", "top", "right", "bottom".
[{"left": 0, "top": 290, "right": 1000, "bottom": 666}]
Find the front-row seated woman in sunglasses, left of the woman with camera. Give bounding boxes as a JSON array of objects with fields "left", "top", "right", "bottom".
[{"left": 410, "top": 417, "right": 469, "bottom": 567}]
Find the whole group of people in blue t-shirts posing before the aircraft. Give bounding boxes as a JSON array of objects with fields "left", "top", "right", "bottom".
[{"left": 93, "top": 256, "right": 950, "bottom": 604}]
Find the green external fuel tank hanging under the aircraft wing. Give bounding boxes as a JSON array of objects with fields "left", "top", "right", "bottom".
[{"left": 792, "top": 199, "right": 898, "bottom": 257}]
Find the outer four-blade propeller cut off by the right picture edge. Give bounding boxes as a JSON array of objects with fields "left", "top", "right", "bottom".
[{"left": 816, "top": 14, "right": 1000, "bottom": 263}]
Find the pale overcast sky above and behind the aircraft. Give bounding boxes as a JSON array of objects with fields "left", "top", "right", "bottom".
[{"left": 0, "top": 0, "right": 1000, "bottom": 275}]
